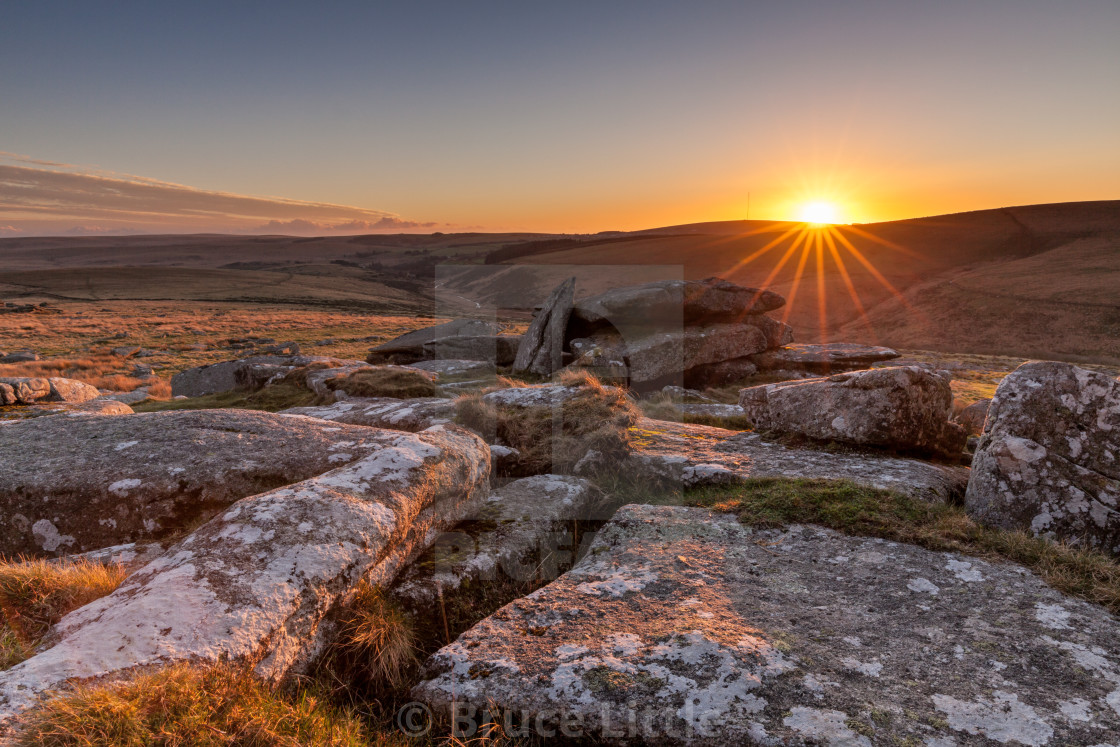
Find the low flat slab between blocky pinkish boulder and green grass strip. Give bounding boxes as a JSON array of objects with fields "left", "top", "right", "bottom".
[{"left": 631, "top": 418, "right": 969, "bottom": 502}]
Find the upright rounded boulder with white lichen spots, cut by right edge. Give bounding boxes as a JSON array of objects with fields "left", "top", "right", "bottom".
[{"left": 965, "top": 362, "right": 1120, "bottom": 554}]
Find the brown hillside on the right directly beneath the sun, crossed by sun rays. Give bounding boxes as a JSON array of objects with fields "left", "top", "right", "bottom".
[{"left": 468, "top": 202, "right": 1120, "bottom": 362}]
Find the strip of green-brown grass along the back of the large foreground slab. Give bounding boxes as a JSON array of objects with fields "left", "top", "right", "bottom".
[{"left": 681, "top": 477, "right": 1120, "bottom": 614}]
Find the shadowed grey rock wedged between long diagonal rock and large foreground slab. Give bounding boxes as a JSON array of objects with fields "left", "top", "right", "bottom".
[{"left": 393, "top": 475, "right": 601, "bottom": 614}]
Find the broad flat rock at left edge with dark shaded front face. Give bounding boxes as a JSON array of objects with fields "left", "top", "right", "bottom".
[{"left": 0, "top": 409, "right": 405, "bottom": 554}]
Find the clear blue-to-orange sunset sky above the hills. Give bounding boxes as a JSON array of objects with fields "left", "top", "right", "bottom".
[{"left": 0, "top": 0, "right": 1120, "bottom": 236}]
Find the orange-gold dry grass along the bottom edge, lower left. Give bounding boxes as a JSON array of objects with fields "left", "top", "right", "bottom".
[{"left": 15, "top": 664, "right": 369, "bottom": 747}]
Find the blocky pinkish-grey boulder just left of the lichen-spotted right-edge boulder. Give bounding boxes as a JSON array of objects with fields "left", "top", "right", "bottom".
[{"left": 739, "top": 366, "right": 967, "bottom": 458}]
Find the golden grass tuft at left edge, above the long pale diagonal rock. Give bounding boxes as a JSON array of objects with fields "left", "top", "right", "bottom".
[{"left": 0, "top": 559, "right": 125, "bottom": 670}]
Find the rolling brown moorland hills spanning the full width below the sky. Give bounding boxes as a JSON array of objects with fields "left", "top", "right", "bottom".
[{"left": 0, "top": 202, "right": 1120, "bottom": 363}]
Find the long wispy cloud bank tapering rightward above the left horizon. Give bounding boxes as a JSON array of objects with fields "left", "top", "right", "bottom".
[{"left": 0, "top": 151, "right": 437, "bottom": 235}]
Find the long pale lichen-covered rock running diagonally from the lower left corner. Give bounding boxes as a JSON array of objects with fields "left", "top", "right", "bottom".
[{"left": 0, "top": 426, "right": 489, "bottom": 729}]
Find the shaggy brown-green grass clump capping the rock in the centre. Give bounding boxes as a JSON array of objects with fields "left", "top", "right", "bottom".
[{"left": 456, "top": 372, "right": 640, "bottom": 475}]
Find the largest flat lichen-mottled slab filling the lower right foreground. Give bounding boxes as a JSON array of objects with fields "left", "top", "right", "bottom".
[{"left": 412, "top": 505, "right": 1120, "bottom": 747}]
